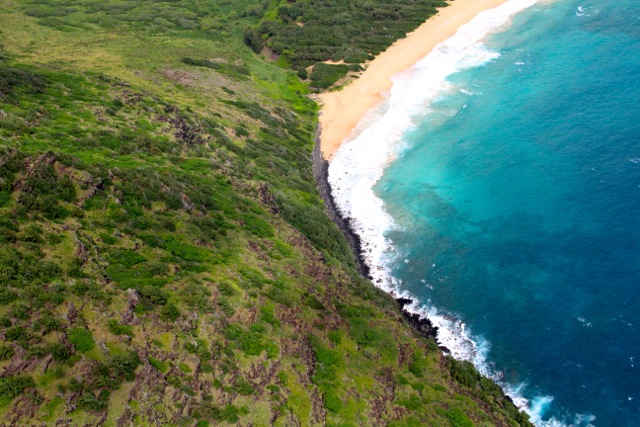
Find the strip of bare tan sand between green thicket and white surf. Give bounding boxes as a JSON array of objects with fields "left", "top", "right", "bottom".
[{"left": 319, "top": 0, "right": 506, "bottom": 160}]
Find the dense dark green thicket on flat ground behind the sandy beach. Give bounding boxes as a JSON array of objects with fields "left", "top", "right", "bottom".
[{"left": 245, "top": 0, "right": 447, "bottom": 89}]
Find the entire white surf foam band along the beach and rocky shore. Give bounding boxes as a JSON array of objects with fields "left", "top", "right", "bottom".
[{"left": 328, "top": 0, "right": 591, "bottom": 426}]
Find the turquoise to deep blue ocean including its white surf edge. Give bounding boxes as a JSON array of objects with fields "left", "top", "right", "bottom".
[{"left": 329, "top": 0, "right": 640, "bottom": 427}]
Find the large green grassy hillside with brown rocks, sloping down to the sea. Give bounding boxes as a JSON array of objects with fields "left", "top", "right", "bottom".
[{"left": 0, "top": 0, "right": 519, "bottom": 426}]
